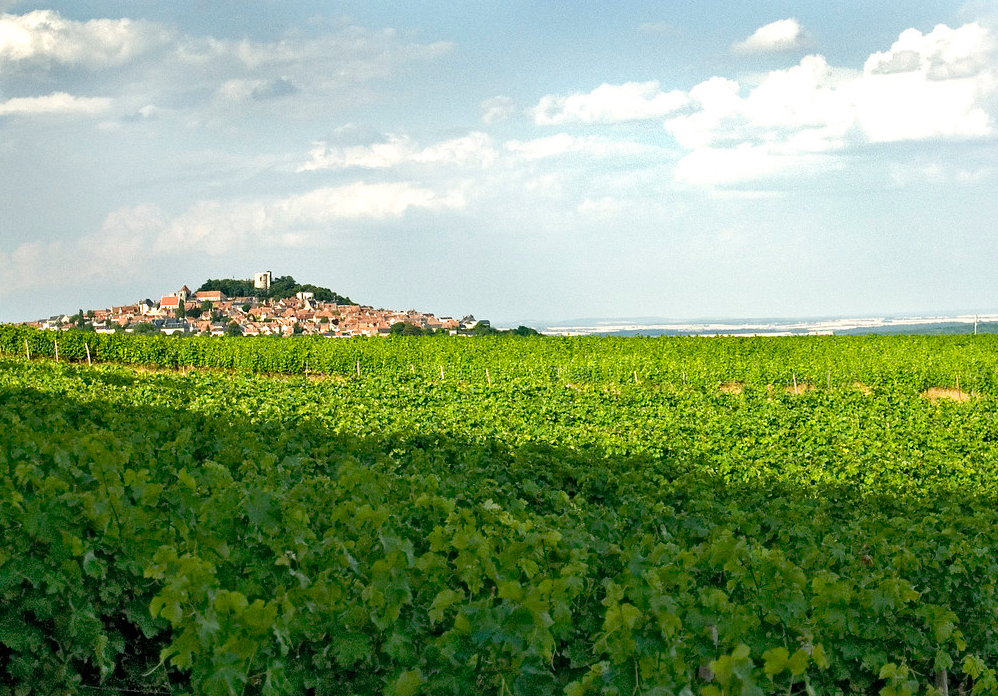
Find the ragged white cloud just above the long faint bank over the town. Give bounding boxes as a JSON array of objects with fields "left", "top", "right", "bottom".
[{"left": 298, "top": 132, "right": 496, "bottom": 172}]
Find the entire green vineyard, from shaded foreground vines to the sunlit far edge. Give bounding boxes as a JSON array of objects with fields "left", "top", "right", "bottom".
[{"left": 0, "top": 326, "right": 998, "bottom": 696}]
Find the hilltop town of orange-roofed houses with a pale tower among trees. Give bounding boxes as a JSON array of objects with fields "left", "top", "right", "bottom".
[{"left": 28, "top": 271, "right": 504, "bottom": 337}]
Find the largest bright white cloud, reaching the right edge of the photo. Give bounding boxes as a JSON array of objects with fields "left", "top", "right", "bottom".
[{"left": 665, "top": 24, "right": 998, "bottom": 185}]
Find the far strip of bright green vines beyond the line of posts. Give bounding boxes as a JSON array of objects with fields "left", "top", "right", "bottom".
[{"left": 0, "top": 325, "right": 998, "bottom": 392}]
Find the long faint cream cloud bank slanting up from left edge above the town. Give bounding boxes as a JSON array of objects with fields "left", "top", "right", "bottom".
[{"left": 0, "top": 182, "right": 466, "bottom": 297}]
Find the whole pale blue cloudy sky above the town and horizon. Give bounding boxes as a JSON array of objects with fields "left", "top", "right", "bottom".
[{"left": 0, "top": 0, "right": 998, "bottom": 325}]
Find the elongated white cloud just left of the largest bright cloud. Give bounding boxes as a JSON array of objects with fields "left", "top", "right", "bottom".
[{"left": 532, "top": 81, "right": 687, "bottom": 126}]
